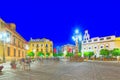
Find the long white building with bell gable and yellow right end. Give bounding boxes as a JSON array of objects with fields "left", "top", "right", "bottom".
[{"left": 82, "top": 31, "right": 120, "bottom": 57}]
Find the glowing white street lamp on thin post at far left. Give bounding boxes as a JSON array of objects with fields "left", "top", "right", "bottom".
[{"left": 0, "top": 31, "right": 10, "bottom": 62}]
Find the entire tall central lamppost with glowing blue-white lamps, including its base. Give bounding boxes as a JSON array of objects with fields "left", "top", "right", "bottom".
[{"left": 72, "top": 30, "right": 82, "bottom": 60}]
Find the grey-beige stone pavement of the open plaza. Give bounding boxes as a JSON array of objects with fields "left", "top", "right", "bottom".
[{"left": 0, "top": 61, "right": 120, "bottom": 80}]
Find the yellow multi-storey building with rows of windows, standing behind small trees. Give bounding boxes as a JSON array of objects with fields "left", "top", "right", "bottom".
[{"left": 28, "top": 38, "right": 53, "bottom": 57}]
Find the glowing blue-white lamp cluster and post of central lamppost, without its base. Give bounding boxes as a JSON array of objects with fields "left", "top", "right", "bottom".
[{"left": 72, "top": 29, "right": 82, "bottom": 54}]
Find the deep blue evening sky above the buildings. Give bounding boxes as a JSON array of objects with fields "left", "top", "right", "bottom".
[{"left": 0, "top": 0, "right": 120, "bottom": 46}]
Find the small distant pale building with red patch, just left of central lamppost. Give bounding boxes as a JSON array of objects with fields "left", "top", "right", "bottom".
[{"left": 61, "top": 44, "right": 75, "bottom": 53}]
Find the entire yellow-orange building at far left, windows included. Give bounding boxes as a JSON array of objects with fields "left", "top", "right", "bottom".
[{"left": 0, "top": 19, "right": 27, "bottom": 61}]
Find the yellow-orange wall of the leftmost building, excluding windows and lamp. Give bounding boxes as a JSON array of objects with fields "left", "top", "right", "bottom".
[{"left": 0, "top": 19, "right": 26, "bottom": 61}]
